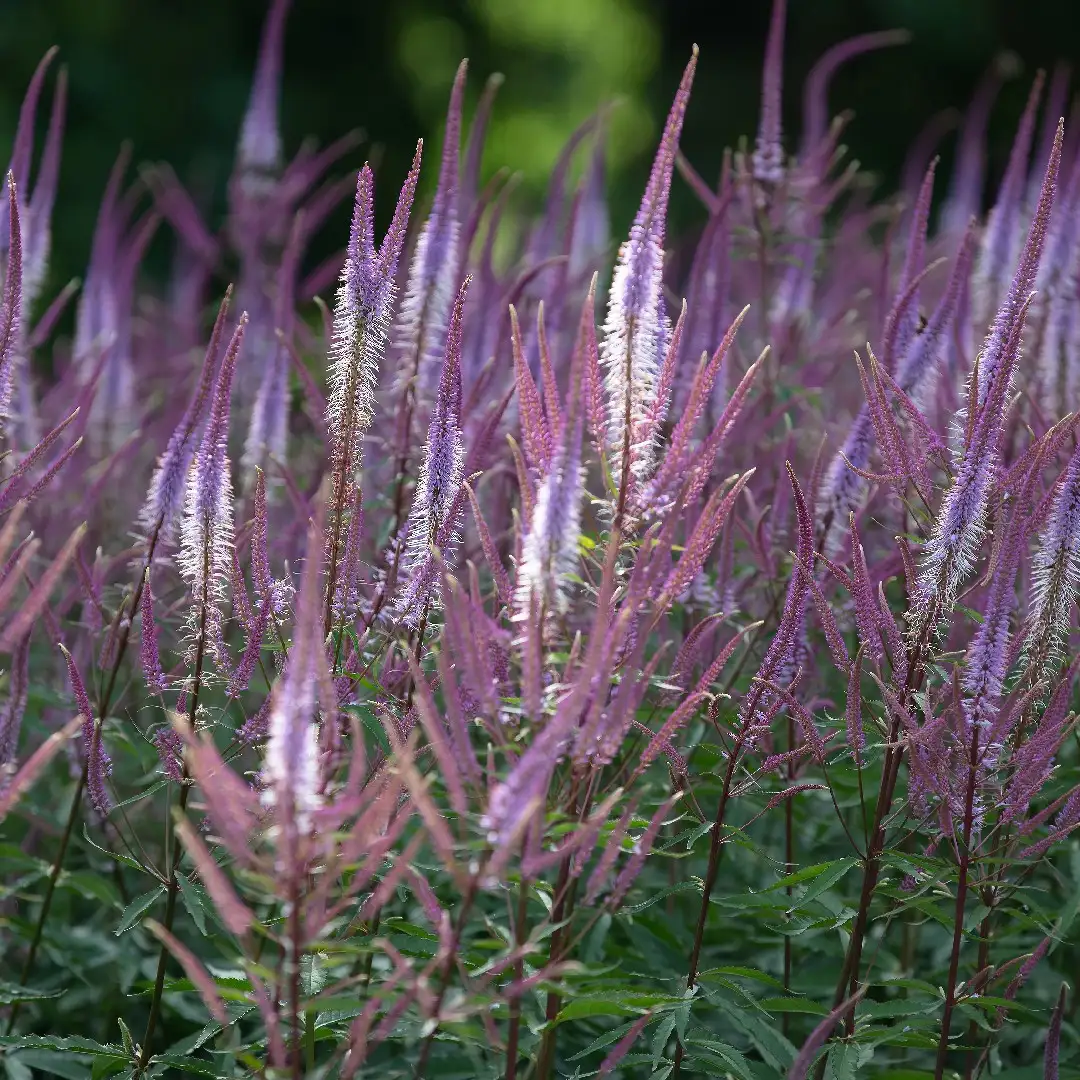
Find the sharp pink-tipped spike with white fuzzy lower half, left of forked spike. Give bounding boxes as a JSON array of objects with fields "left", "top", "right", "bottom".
[{"left": 177, "top": 311, "right": 247, "bottom": 662}]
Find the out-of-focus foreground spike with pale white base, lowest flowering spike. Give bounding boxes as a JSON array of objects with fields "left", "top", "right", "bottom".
[{"left": 264, "top": 496, "right": 326, "bottom": 838}]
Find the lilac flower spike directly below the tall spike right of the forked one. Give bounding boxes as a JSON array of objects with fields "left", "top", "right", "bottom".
[{"left": 401, "top": 278, "right": 471, "bottom": 625}]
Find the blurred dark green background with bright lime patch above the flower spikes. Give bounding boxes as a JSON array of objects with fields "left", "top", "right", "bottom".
[{"left": 0, "top": 0, "right": 1080, "bottom": 300}]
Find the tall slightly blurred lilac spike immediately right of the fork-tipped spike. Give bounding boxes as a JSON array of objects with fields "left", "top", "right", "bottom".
[{"left": 394, "top": 60, "right": 469, "bottom": 393}]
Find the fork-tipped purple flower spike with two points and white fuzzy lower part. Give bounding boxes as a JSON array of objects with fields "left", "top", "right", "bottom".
[{"left": 326, "top": 143, "right": 423, "bottom": 486}]
